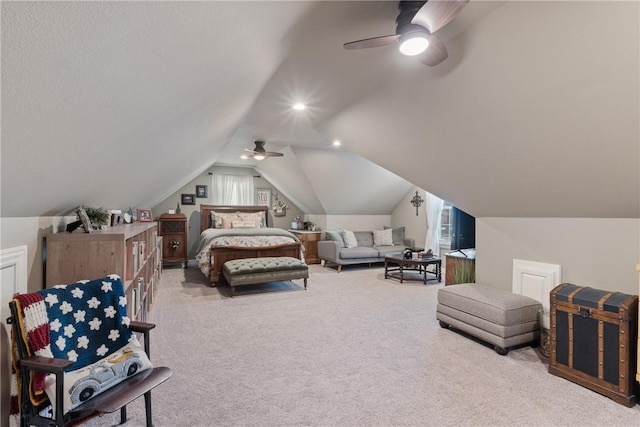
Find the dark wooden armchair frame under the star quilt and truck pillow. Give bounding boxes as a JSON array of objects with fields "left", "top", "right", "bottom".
[{"left": 7, "top": 278, "right": 172, "bottom": 427}]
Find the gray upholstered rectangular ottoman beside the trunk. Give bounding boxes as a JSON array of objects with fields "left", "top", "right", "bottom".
[{"left": 436, "top": 283, "right": 542, "bottom": 355}]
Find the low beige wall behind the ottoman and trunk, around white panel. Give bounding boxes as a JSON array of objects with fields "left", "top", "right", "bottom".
[{"left": 476, "top": 218, "right": 640, "bottom": 295}]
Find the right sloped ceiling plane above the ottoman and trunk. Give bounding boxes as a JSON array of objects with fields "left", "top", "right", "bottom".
[{"left": 323, "top": 1, "right": 640, "bottom": 218}]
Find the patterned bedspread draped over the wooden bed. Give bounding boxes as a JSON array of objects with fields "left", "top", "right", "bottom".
[{"left": 196, "top": 228, "right": 302, "bottom": 277}]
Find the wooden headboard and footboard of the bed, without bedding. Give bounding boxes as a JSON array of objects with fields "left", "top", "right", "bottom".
[{"left": 200, "top": 205, "right": 302, "bottom": 287}]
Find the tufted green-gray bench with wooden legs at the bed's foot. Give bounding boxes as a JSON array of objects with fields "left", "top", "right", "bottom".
[{"left": 222, "top": 257, "right": 309, "bottom": 297}]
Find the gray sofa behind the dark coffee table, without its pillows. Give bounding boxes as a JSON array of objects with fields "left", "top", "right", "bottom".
[{"left": 318, "top": 227, "right": 415, "bottom": 273}]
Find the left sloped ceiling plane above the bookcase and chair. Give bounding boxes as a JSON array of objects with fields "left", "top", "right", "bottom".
[{"left": 1, "top": 2, "right": 312, "bottom": 217}]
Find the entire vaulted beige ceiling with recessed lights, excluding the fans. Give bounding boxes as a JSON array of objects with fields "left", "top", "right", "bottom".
[{"left": 0, "top": 0, "right": 640, "bottom": 218}]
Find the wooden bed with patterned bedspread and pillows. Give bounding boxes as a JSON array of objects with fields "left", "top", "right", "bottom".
[{"left": 196, "top": 205, "right": 304, "bottom": 286}]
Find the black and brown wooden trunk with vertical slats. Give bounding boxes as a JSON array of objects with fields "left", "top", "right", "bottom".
[{"left": 549, "top": 283, "right": 638, "bottom": 407}]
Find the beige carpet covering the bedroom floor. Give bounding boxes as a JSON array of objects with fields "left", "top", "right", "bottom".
[{"left": 88, "top": 265, "right": 640, "bottom": 427}]
